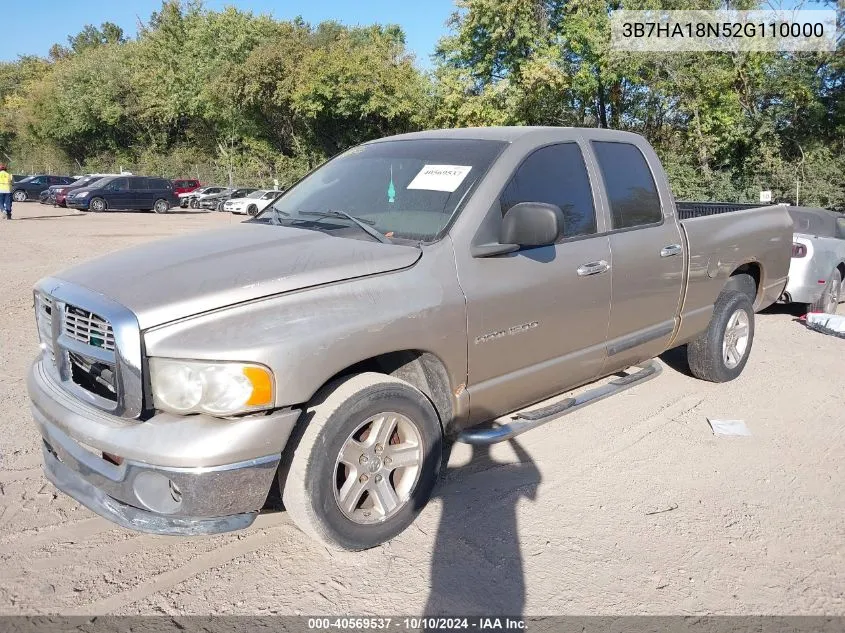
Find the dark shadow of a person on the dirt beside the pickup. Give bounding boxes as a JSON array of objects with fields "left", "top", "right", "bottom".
[{"left": 423, "top": 440, "right": 542, "bottom": 616}]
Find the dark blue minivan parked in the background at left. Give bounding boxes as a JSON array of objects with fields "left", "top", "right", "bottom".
[{"left": 67, "top": 176, "right": 179, "bottom": 213}]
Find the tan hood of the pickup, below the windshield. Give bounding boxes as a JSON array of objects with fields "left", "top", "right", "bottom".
[{"left": 53, "top": 224, "right": 422, "bottom": 329}]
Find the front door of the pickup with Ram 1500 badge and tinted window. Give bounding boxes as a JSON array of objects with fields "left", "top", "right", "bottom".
[{"left": 456, "top": 142, "right": 611, "bottom": 422}]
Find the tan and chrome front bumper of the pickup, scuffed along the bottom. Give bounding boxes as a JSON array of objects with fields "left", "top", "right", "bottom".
[{"left": 27, "top": 362, "right": 300, "bottom": 535}]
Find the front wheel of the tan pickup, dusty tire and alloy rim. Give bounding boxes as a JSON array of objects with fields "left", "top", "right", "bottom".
[{"left": 279, "top": 372, "right": 443, "bottom": 551}]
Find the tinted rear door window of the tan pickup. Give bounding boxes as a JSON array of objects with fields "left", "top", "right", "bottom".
[{"left": 593, "top": 141, "right": 663, "bottom": 229}]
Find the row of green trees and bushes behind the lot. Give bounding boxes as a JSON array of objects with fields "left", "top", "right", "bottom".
[{"left": 0, "top": 0, "right": 845, "bottom": 208}]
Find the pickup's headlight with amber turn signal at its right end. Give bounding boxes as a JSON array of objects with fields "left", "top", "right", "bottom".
[{"left": 150, "top": 358, "right": 273, "bottom": 415}]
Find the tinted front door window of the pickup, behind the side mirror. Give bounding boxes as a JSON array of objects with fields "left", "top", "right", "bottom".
[{"left": 500, "top": 143, "right": 596, "bottom": 238}]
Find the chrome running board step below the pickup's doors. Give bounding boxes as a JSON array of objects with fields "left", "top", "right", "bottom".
[{"left": 457, "top": 360, "right": 663, "bottom": 445}]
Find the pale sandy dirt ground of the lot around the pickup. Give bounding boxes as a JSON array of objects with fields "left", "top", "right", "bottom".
[{"left": 0, "top": 203, "right": 845, "bottom": 615}]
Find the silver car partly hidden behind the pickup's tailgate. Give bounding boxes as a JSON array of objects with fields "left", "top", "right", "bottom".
[{"left": 781, "top": 207, "right": 845, "bottom": 314}]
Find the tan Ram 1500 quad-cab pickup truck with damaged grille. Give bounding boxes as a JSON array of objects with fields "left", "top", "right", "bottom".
[{"left": 28, "top": 127, "right": 792, "bottom": 550}]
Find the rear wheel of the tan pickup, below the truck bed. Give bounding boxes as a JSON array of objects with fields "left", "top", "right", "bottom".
[{"left": 687, "top": 288, "right": 754, "bottom": 382}]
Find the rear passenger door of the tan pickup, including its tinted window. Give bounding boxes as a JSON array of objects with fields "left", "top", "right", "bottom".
[{"left": 591, "top": 141, "right": 684, "bottom": 374}]
